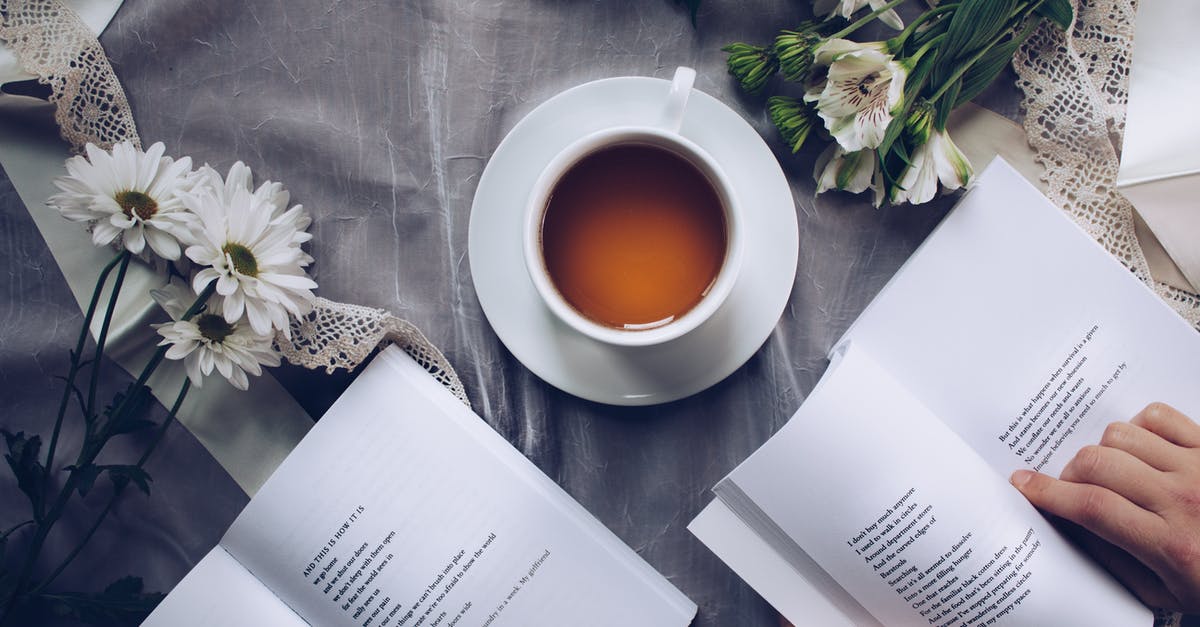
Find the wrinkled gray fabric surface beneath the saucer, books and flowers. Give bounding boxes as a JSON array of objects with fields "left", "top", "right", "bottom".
[{"left": 0, "top": 0, "right": 1016, "bottom": 626}]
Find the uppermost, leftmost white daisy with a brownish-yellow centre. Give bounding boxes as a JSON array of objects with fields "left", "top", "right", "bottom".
[{"left": 47, "top": 142, "right": 196, "bottom": 259}]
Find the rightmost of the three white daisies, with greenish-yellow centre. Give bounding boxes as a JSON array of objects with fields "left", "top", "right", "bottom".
[{"left": 184, "top": 166, "right": 317, "bottom": 336}]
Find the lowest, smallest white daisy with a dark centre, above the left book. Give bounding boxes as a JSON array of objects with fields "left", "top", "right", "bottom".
[{"left": 150, "top": 283, "right": 280, "bottom": 389}]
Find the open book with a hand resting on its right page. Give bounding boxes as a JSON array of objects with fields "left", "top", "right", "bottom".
[{"left": 690, "top": 160, "right": 1200, "bottom": 626}]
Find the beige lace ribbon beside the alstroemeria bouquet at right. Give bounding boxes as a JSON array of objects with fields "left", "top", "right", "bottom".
[{"left": 1013, "top": 0, "right": 1200, "bottom": 327}]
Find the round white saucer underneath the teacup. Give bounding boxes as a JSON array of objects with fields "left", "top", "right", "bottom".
[{"left": 468, "top": 77, "right": 799, "bottom": 405}]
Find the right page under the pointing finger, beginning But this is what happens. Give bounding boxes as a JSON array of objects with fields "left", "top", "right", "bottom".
[{"left": 842, "top": 160, "right": 1200, "bottom": 476}]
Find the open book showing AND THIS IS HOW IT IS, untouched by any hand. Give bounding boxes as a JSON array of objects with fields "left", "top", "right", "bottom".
[{"left": 145, "top": 347, "right": 696, "bottom": 627}]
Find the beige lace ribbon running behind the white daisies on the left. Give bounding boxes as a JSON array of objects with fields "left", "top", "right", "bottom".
[{"left": 0, "top": 0, "right": 470, "bottom": 405}]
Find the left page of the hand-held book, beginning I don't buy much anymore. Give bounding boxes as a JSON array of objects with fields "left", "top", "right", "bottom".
[{"left": 716, "top": 344, "right": 1152, "bottom": 627}]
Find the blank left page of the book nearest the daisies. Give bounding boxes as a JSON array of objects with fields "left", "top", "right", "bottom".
[{"left": 142, "top": 545, "right": 307, "bottom": 627}]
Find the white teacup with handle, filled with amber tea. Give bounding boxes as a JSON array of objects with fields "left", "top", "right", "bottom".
[{"left": 524, "top": 67, "right": 742, "bottom": 346}]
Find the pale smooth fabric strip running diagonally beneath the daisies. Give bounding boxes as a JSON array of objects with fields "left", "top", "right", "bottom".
[{"left": 0, "top": 96, "right": 312, "bottom": 496}]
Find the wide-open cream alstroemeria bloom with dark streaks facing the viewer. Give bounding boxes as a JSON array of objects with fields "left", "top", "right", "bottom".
[{"left": 804, "top": 40, "right": 908, "bottom": 153}]
